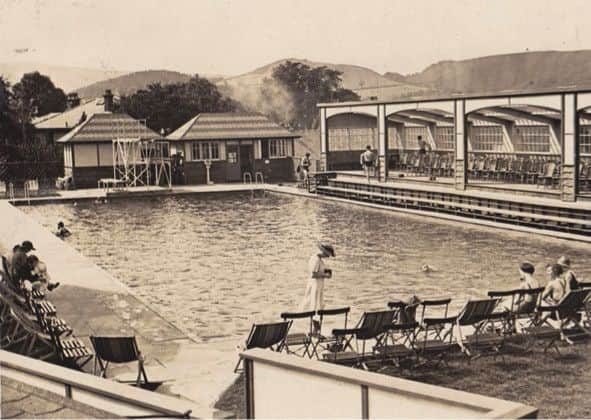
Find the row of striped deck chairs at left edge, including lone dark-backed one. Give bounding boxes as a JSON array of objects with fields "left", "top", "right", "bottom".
[{"left": 0, "top": 256, "right": 153, "bottom": 388}]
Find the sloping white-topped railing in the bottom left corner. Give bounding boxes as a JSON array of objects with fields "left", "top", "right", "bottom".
[{"left": 0, "top": 350, "right": 224, "bottom": 418}]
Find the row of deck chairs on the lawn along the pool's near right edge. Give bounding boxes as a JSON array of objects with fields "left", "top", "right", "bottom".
[{"left": 236, "top": 284, "right": 591, "bottom": 369}]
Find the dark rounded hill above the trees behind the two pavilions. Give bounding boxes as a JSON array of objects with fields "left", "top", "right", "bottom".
[{"left": 77, "top": 70, "right": 191, "bottom": 98}]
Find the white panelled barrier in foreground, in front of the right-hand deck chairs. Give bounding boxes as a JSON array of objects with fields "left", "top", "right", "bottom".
[{"left": 241, "top": 349, "right": 538, "bottom": 419}]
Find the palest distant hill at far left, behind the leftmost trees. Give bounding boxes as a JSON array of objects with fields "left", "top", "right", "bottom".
[{"left": 0, "top": 63, "right": 126, "bottom": 93}]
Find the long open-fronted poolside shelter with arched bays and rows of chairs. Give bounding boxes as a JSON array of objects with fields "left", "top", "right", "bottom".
[{"left": 318, "top": 89, "right": 591, "bottom": 201}]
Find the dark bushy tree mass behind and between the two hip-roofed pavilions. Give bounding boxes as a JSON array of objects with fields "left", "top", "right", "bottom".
[{"left": 120, "top": 75, "right": 239, "bottom": 132}]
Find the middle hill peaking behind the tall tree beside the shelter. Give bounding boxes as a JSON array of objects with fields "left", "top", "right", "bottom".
[{"left": 219, "top": 58, "right": 425, "bottom": 99}]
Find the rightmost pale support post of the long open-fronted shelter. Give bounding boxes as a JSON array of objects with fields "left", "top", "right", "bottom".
[{"left": 560, "top": 93, "right": 579, "bottom": 201}]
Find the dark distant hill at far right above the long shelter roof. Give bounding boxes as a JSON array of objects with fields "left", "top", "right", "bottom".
[{"left": 385, "top": 50, "right": 591, "bottom": 93}]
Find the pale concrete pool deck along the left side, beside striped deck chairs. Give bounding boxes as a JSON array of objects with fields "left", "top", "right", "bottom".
[{"left": 0, "top": 201, "right": 237, "bottom": 417}]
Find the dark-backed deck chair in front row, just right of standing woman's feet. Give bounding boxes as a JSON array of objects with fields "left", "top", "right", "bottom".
[{"left": 323, "top": 310, "right": 398, "bottom": 370}]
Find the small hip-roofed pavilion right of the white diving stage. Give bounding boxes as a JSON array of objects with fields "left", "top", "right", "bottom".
[{"left": 166, "top": 113, "right": 300, "bottom": 184}]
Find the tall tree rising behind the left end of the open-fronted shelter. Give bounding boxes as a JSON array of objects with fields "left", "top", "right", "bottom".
[{"left": 262, "top": 61, "right": 359, "bottom": 129}]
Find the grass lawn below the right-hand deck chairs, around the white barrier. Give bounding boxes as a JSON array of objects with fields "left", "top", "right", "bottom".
[{"left": 216, "top": 342, "right": 591, "bottom": 418}]
